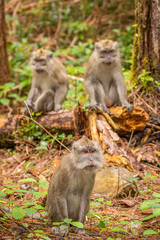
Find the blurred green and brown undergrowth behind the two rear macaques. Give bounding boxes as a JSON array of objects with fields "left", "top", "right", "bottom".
[{"left": 0, "top": 0, "right": 135, "bottom": 112}]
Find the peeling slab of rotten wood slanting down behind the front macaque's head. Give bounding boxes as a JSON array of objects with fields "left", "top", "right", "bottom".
[{"left": 90, "top": 113, "right": 136, "bottom": 171}]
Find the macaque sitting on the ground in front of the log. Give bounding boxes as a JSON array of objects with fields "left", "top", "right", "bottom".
[{"left": 47, "top": 136, "right": 104, "bottom": 236}]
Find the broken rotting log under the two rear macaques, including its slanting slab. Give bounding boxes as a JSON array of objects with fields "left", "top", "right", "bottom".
[{"left": 0, "top": 104, "right": 149, "bottom": 170}]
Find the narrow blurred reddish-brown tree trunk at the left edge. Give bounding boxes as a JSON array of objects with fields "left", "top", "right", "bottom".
[{"left": 0, "top": 0, "right": 10, "bottom": 85}]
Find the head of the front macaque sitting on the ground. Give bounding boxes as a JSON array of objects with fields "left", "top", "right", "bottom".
[{"left": 71, "top": 136, "right": 104, "bottom": 172}]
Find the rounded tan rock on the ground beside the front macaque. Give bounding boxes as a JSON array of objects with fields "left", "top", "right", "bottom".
[{"left": 93, "top": 166, "right": 138, "bottom": 198}]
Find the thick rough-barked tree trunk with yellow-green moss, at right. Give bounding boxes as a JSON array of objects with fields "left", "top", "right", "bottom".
[{"left": 132, "top": 0, "right": 160, "bottom": 81}]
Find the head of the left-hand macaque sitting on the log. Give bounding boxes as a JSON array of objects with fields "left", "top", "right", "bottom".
[{"left": 31, "top": 48, "right": 53, "bottom": 73}]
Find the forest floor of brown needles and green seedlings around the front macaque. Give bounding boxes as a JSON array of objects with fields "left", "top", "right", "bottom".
[{"left": 0, "top": 91, "right": 160, "bottom": 240}]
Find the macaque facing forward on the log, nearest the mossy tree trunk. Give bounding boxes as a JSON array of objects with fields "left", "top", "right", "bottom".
[{"left": 84, "top": 39, "right": 133, "bottom": 113}]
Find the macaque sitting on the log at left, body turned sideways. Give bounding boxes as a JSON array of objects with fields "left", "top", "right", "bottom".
[{"left": 26, "top": 49, "right": 68, "bottom": 112}]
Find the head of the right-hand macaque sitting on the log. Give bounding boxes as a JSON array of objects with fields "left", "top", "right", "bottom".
[{"left": 94, "top": 39, "right": 119, "bottom": 64}]
